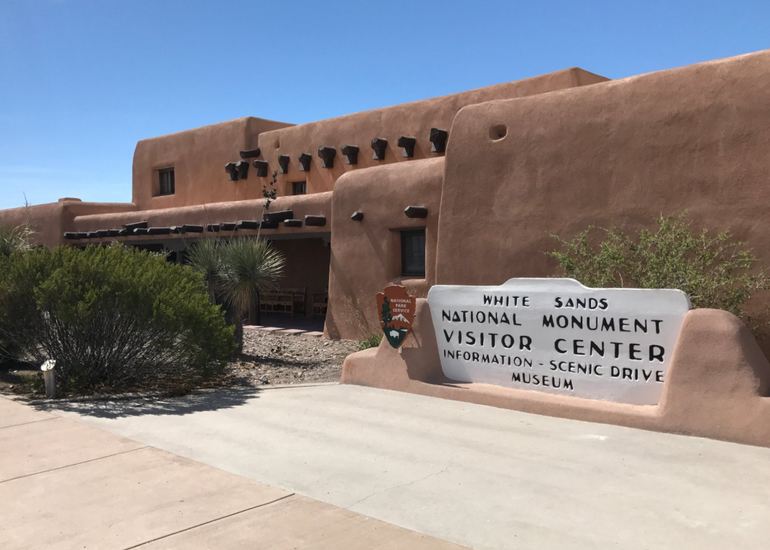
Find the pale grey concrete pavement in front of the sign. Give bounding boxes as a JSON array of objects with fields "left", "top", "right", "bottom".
[{"left": 42, "top": 385, "right": 770, "bottom": 550}]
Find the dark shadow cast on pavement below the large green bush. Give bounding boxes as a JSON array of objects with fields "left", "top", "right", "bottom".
[{"left": 29, "top": 387, "right": 259, "bottom": 418}]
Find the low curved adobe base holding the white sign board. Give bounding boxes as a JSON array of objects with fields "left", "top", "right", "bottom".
[{"left": 341, "top": 299, "right": 770, "bottom": 447}]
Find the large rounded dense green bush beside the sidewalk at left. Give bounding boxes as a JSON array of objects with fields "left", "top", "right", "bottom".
[{"left": 0, "top": 246, "right": 234, "bottom": 392}]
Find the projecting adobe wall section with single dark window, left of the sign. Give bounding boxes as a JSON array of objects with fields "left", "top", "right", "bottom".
[{"left": 326, "top": 158, "right": 444, "bottom": 339}]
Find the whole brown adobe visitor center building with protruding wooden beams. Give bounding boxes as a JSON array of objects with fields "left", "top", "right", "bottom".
[{"left": 0, "top": 52, "right": 770, "bottom": 350}]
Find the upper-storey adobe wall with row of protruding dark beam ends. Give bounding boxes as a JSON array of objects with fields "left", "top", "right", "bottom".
[{"left": 255, "top": 68, "right": 607, "bottom": 194}]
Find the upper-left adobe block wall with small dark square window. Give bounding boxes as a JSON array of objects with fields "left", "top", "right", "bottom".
[{"left": 133, "top": 117, "right": 287, "bottom": 210}]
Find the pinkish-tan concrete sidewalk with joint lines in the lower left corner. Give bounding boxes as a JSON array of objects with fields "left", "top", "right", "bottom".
[{"left": 0, "top": 397, "right": 459, "bottom": 550}]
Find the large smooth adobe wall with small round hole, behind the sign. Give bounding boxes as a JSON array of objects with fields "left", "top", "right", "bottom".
[{"left": 436, "top": 51, "right": 770, "bottom": 284}]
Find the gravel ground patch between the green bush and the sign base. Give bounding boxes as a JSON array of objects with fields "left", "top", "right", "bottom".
[{"left": 229, "top": 327, "right": 359, "bottom": 385}]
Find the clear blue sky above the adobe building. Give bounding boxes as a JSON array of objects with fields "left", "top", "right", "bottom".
[{"left": 0, "top": 0, "right": 770, "bottom": 208}]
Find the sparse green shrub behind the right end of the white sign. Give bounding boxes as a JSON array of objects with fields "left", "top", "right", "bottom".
[{"left": 548, "top": 214, "right": 769, "bottom": 317}]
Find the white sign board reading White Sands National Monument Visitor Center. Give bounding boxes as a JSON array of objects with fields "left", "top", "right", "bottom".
[{"left": 428, "top": 279, "right": 690, "bottom": 405}]
